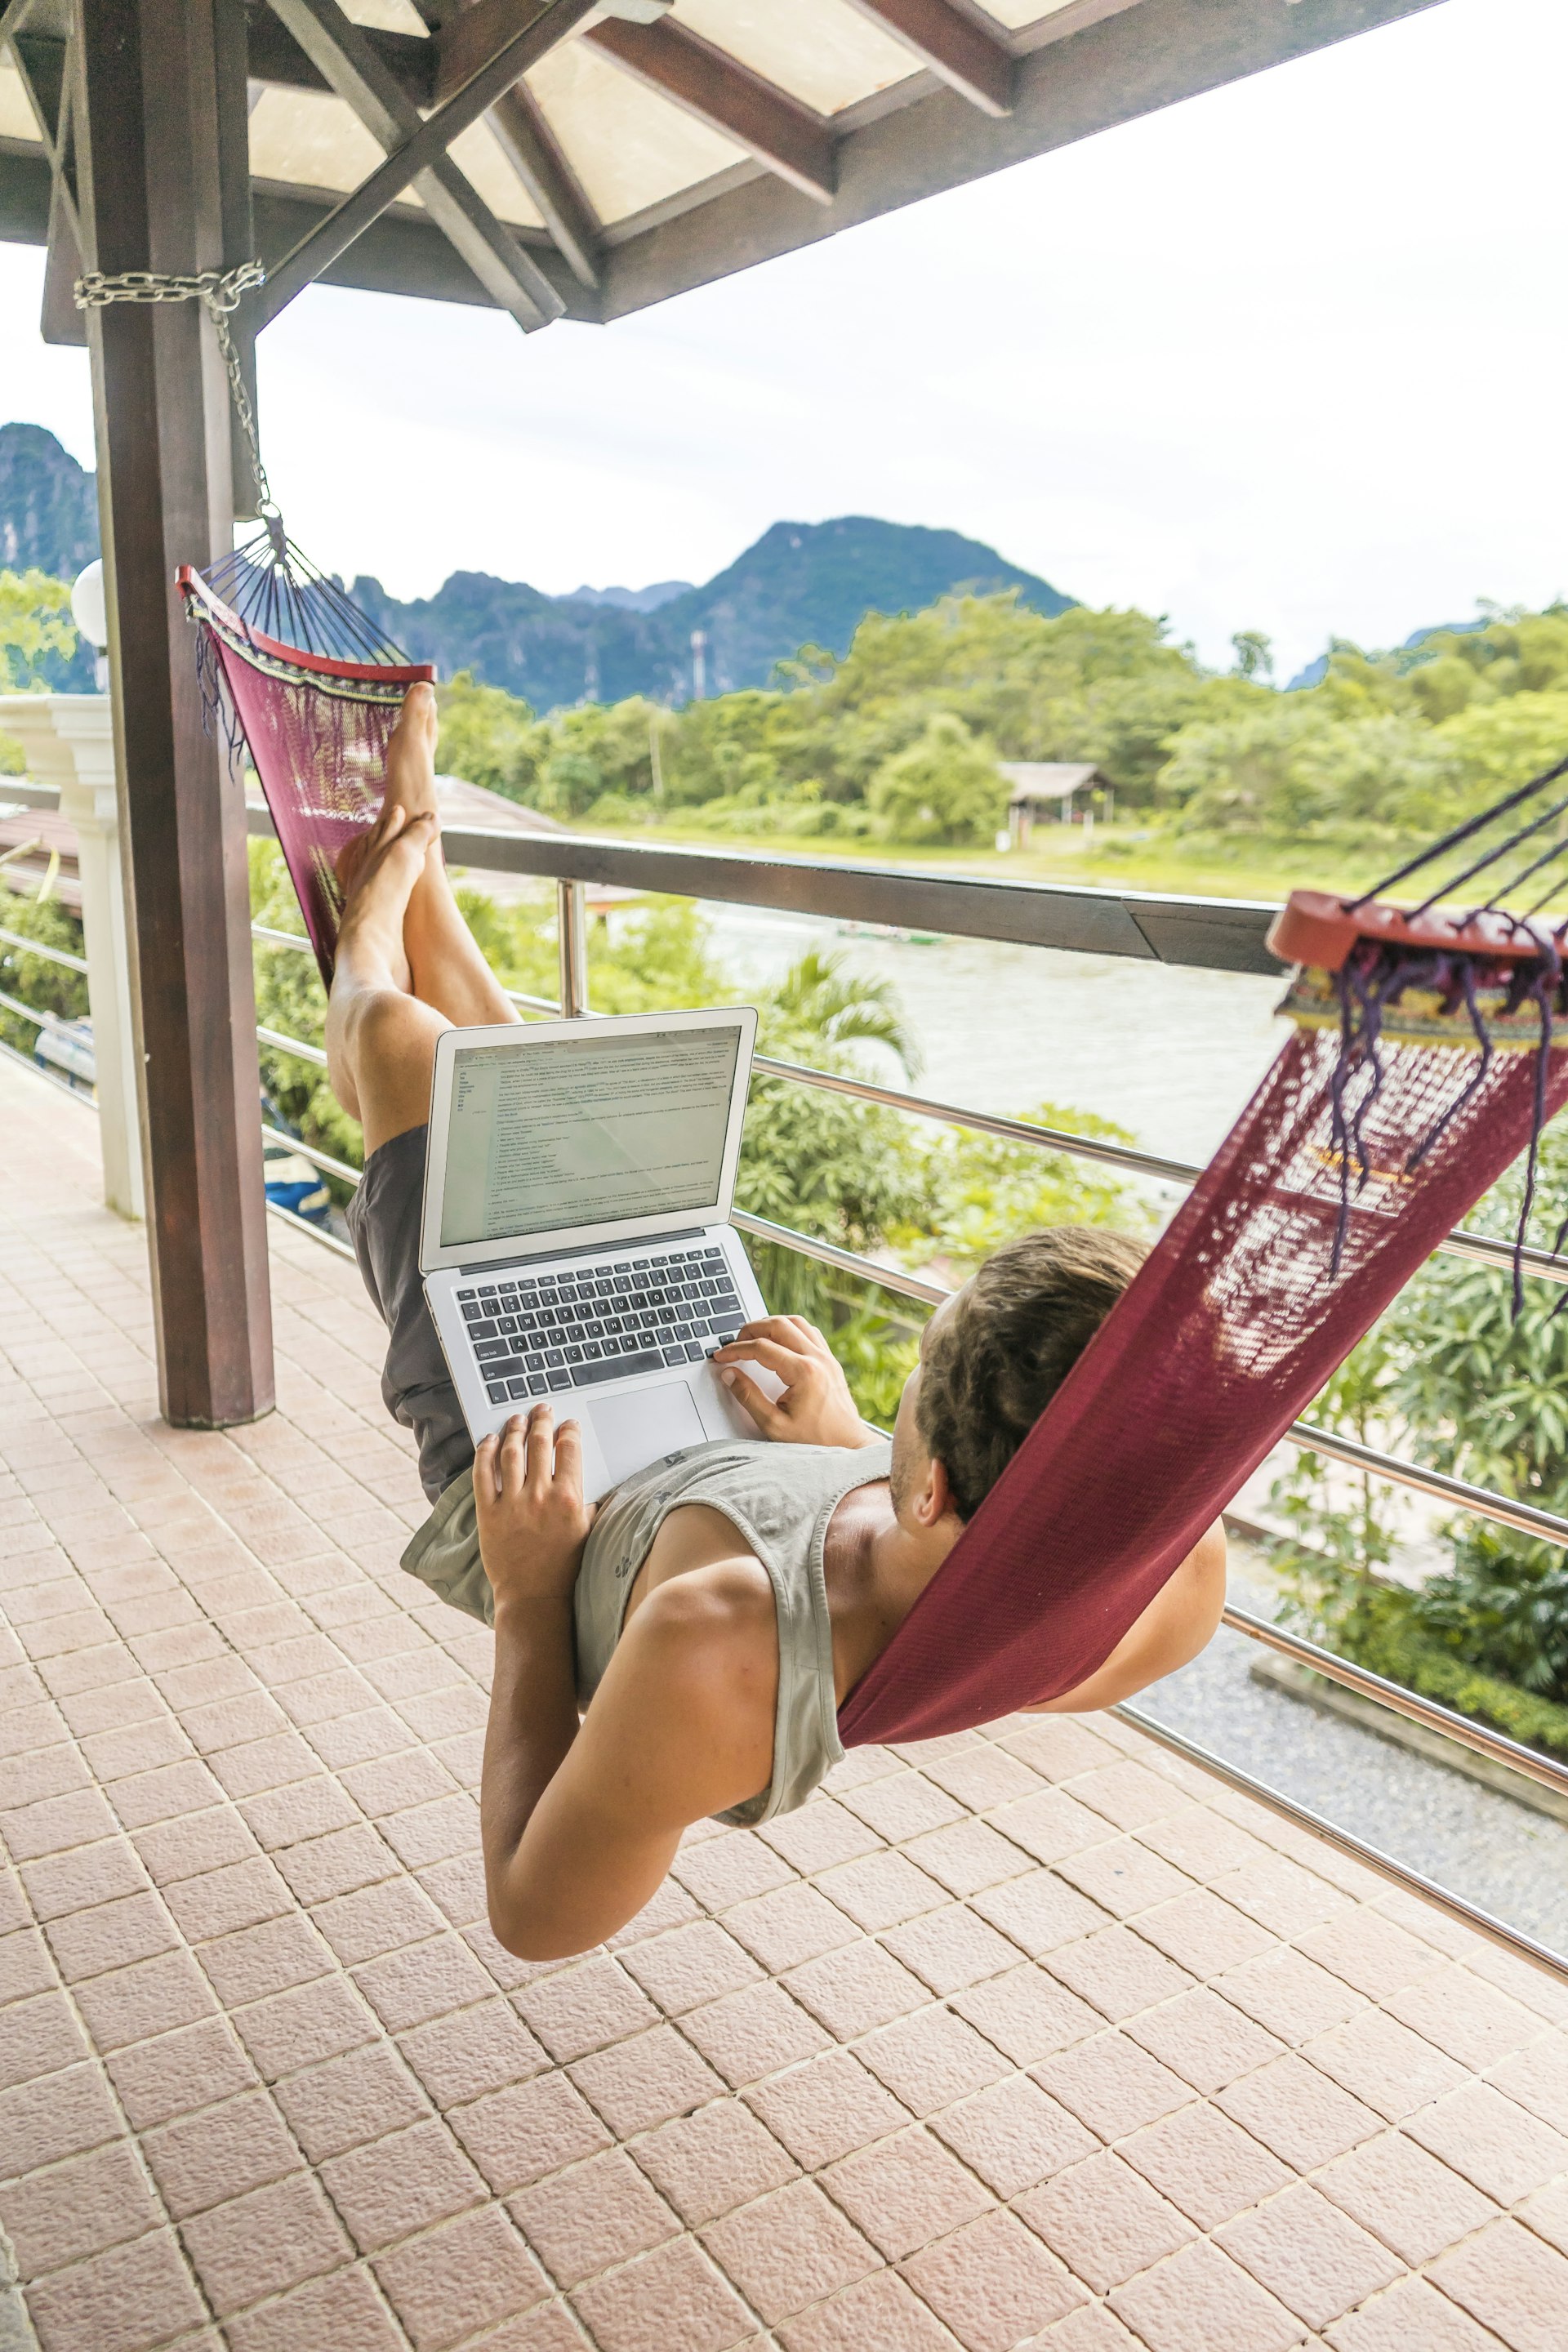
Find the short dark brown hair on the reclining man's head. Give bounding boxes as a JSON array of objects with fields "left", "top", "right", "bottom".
[{"left": 915, "top": 1225, "right": 1150, "bottom": 1519}]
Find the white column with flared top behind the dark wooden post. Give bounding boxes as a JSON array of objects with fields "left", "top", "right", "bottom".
[{"left": 0, "top": 694, "right": 145, "bottom": 1218}]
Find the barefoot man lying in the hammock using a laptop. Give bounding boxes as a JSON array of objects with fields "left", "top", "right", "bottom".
[{"left": 327, "top": 687, "right": 1225, "bottom": 1959}]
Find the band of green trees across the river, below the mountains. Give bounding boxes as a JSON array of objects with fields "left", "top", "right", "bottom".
[{"left": 439, "top": 593, "right": 1568, "bottom": 853}]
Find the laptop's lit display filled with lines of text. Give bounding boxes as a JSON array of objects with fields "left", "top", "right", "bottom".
[{"left": 442, "top": 1023, "right": 741, "bottom": 1249}]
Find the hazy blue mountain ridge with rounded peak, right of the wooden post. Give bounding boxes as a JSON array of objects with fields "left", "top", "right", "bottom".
[{"left": 353, "top": 515, "right": 1072, "bottom": 710}]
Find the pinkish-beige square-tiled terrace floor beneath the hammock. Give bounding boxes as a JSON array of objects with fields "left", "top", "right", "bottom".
[{"left": 0, "top": 1066, "right": 1568, "bottom": 2352}]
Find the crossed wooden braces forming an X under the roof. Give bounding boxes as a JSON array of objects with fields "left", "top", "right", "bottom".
[{"left": 263, "top": 0, "right": 592, "bottom": 327}]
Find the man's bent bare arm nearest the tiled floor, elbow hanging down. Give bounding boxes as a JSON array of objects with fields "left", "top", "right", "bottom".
[{"left": 474, "top": 1406, "right": 778, "bottom": 1959}]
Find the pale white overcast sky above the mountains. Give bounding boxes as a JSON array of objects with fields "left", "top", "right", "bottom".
[{"left": 0, "top": 0, "right": 1568, "bottom": 677}]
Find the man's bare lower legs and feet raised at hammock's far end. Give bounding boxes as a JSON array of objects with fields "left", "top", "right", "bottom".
[{"left": 327, "top": 687, "right": 517, "bottom": 1157}]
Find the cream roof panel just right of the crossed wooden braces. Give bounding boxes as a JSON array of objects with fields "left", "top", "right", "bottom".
[{"left": 529, "top": 40, "right": 747, "bottom": 225}]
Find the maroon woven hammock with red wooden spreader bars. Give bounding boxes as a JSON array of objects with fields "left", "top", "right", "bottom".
[{"left": 181, "top": 541, "right": 1568, "bottom": 1745}]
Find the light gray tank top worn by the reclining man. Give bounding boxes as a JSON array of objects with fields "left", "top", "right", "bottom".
[{"left": 576, "top": 1437, "right": 893, "bottom": 1828}]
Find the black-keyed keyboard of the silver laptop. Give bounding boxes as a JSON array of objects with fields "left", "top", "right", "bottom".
[{"left": 456, "top": 1249, "right": 746, "bottom": 1404}]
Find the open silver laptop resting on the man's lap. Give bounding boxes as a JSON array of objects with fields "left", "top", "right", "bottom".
[{"left": 418, "top": 1004, "right": 778, "bottom": 1496}]
